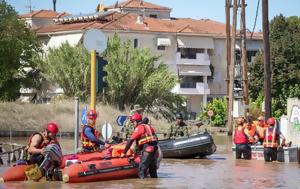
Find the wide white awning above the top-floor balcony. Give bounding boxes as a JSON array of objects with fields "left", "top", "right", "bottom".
[{"left": 177, "top": 36, "right": 214, "bottom": 49}]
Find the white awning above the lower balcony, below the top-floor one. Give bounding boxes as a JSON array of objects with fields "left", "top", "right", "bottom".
[{"left": 178, "top": 65, "right": 211, "bottom": 76}]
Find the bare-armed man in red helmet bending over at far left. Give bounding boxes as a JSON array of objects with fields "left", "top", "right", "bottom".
[{"left": 26, "top": 122, "right": 59, "bottom": 165}]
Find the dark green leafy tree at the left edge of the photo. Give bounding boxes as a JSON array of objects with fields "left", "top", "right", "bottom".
[{"left": 0, "top": 0, "right": 41, "bottom": 100}]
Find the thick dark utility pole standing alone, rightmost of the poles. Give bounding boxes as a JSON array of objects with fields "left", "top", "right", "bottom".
[{"left": 262, "top": 0, "right": 272, "bottom": 118}]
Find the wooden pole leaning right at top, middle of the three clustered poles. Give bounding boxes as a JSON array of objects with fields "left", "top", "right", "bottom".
[{"left": 227, "top": 0, "right": 237, "bottom": 134}]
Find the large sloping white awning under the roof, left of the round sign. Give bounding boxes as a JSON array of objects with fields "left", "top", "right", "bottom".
[{"left": 47, "top": 33, "right": 83, "bottom": 49}]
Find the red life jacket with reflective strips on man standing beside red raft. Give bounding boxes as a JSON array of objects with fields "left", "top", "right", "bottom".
[{"left": 137, "top": 124, "right": 158, "bottom": 148}]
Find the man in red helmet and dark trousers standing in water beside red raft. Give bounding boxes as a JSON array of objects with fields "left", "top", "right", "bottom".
[{"left": 122, "top": 113, "right": 158, "bottom": 179}]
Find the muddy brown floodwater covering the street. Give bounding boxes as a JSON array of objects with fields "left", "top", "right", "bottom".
[{"left": 0, "top": 135, "right": 300, "bottom": 189}]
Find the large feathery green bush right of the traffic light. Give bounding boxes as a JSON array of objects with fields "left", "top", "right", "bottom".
[{"left": 104, "top": 34, "right": 183, "bottom": 114}]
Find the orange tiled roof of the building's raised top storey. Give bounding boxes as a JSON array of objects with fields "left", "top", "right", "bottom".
[{"left": 106, "top": 0, "right": 171, "bottom": 10}]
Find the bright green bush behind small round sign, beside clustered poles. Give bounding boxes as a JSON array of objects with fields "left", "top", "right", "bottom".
[{"left": 199, "top": 98, "right": 227, "bottom": 126}]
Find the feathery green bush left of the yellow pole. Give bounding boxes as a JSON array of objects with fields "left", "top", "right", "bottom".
[{"left": 36, "top": 43, "right": 90, "bottom": 99}]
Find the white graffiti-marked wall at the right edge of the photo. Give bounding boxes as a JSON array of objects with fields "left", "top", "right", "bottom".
[{"left": 286, "top": 98, "right": 300, "bottom": 147}]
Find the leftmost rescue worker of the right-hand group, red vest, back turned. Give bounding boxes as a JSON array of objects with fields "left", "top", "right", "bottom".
[{"left": 233, "top": 117, "right": 251, "bottom": 159}]
